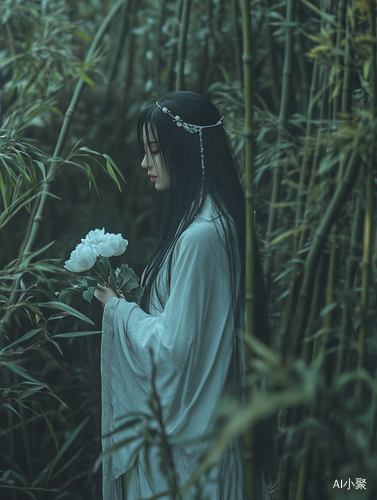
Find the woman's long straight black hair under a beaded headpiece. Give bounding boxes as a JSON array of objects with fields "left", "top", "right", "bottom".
[{"left": 137, "top": 91, "right": 272, "bottom": 479}]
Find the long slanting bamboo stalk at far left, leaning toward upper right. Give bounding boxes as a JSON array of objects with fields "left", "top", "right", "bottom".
[{"left": 0, "top": 0, "right": 124, "bottom": 345}]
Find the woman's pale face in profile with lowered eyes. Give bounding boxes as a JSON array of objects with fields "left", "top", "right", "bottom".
[{"left": 141, "top": 127, "right": 170, "bottom": 191}]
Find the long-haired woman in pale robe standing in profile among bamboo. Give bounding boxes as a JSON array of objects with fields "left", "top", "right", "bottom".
[{"left": 95, "top": 91, "right": 271, "bottom": 500}]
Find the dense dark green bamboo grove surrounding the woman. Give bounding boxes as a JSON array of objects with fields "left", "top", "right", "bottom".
[{"left": 0, "top": 0, "right": 377, "bottom": 500}]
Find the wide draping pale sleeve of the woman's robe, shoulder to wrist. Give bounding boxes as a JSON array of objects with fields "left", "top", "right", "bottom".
[{"left": 104, "top": 221, "right": 239, "bottom": 476}]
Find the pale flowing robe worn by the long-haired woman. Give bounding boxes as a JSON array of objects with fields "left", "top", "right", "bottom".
[{"left": 101, "top": 202, "right": 264, "bottom": 500}]
